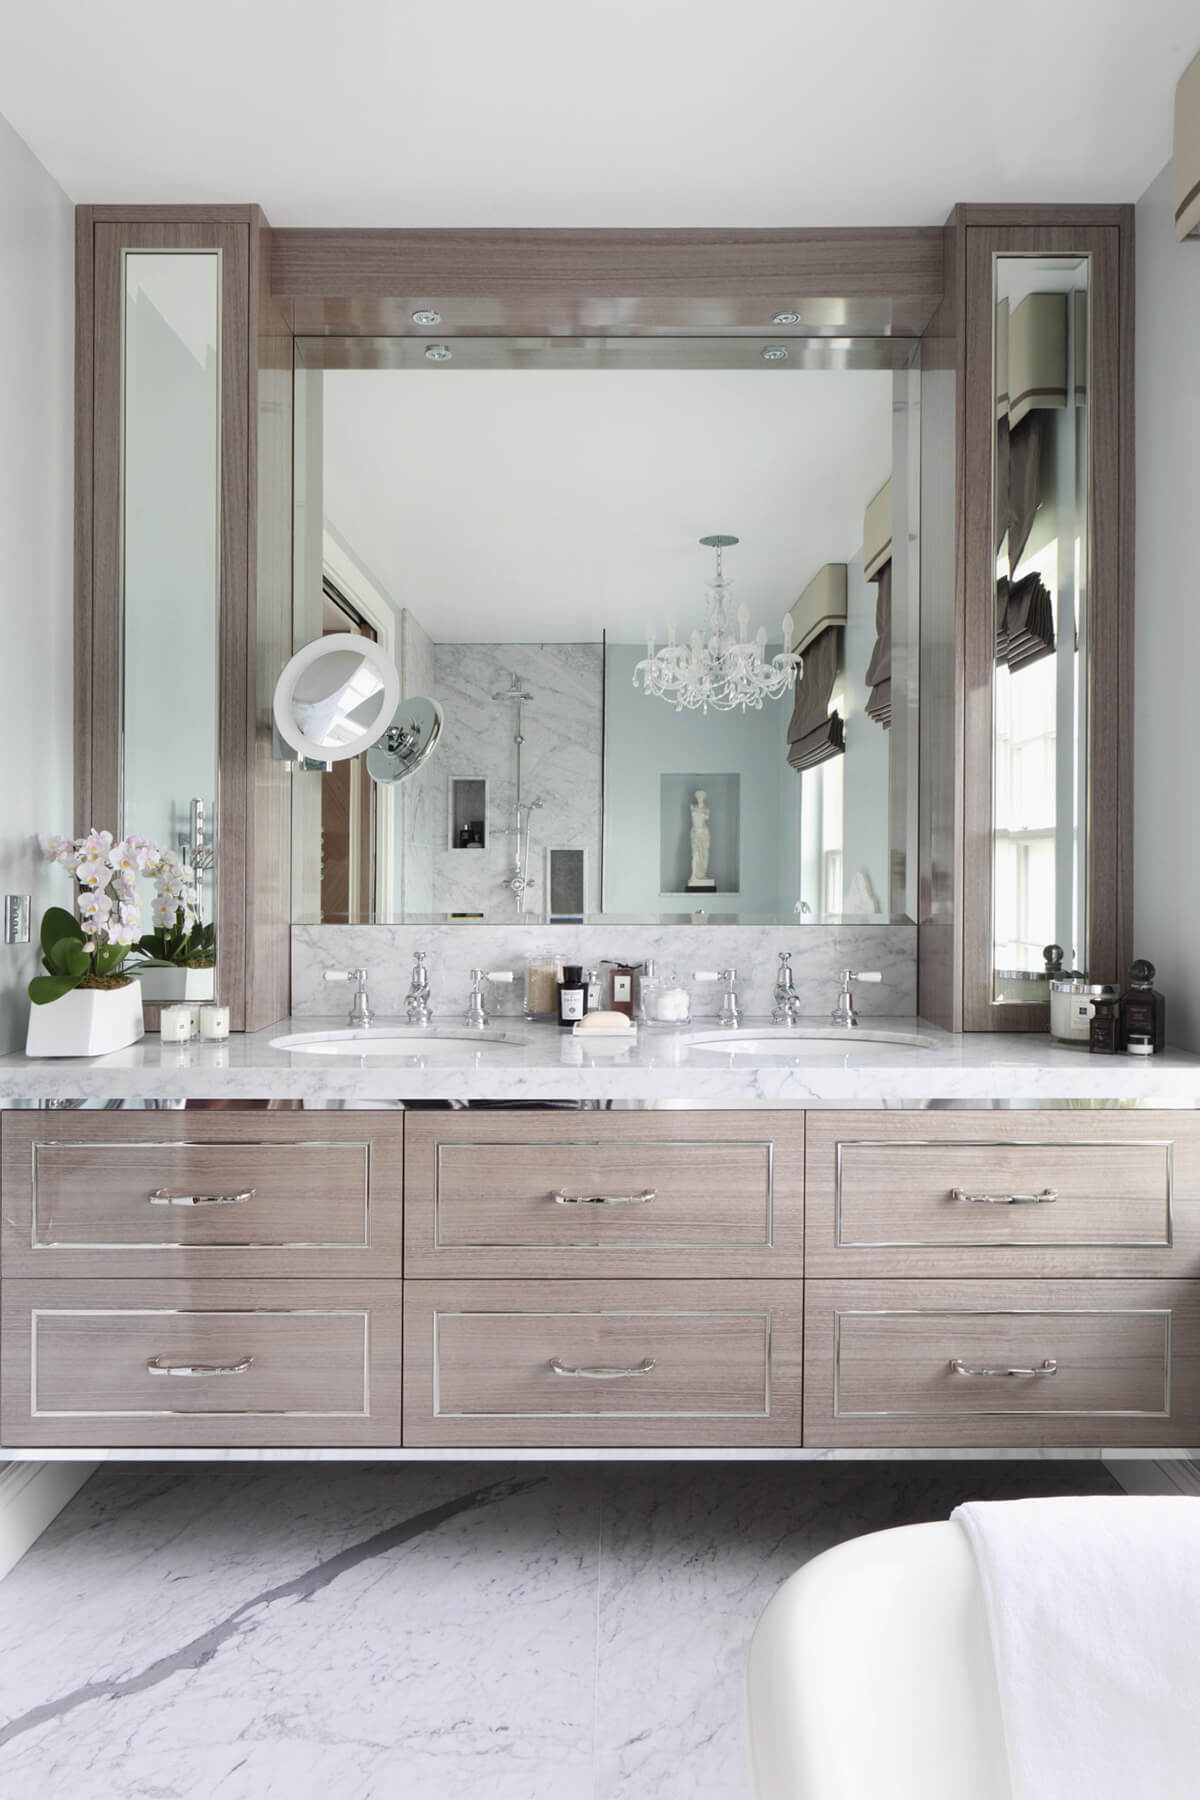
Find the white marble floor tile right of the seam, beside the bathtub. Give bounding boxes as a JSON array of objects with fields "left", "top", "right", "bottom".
[{"left": 594, "top": 1463, "right": 1115, "bottom": 1800}]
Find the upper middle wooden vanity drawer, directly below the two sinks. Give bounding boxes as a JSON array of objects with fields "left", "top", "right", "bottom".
[{"left": 405, "top": 1112, "right": 804, "bottom": 1278}]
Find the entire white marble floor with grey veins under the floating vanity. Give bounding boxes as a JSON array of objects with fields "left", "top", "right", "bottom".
[{"left": 0, "top": 1462, "right": 1112, "bottom": 1800}]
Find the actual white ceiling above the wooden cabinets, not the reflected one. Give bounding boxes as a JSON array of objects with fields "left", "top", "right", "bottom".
[{"left": 0, "top": 0, "right": 1200, "bottom": 227}]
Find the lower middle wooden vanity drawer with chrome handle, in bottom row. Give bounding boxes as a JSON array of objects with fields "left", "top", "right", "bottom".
[{"left": 405, "top": 1282, "right": 801, "bottom": 1447}]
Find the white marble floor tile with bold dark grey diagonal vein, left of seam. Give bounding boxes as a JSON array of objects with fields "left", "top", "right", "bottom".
[{"left": 0, "top": 1465, "right": 599, "bottom": 1800}]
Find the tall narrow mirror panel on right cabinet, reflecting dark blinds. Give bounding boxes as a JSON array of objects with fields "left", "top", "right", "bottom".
[{"left": 991, "top": 256, "right": 1090, "bottom": 1004}]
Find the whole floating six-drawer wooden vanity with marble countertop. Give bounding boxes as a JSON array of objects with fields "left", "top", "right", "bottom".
[{"left": 0, "top": 1019, "right": 1200, "bottom": 1456}]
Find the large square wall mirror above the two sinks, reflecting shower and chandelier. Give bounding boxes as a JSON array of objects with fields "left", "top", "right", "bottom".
[{"left": 293, "top": 338, "right": 919, "bottom": 923}]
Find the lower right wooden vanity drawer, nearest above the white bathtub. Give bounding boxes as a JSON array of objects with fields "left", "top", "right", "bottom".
[{"left": 804, "top": 1280, "right": 1200, "bottom": 1449}]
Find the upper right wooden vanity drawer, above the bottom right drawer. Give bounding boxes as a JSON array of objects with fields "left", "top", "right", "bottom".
[{"left": 806, "top": 1111, "right": 1200, "bottom": 1278}]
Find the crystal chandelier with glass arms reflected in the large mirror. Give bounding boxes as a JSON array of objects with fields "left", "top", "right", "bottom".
[{"left": 633, "top": 536, "right": 804, "bottom": 713}]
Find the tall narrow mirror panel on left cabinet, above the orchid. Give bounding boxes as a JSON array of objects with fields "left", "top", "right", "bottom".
[{"left": 121, "top": 250, "right": 221, "bottom": 979}]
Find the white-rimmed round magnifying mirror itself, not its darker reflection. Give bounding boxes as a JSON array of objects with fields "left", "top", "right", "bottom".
[{"left": 275, "top": 632, "right": 399, "bottom": 763}]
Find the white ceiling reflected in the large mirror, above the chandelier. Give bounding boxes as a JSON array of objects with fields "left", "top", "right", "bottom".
[{"left": 318, "top": 367, "right": 892, "bottom": 643}]
